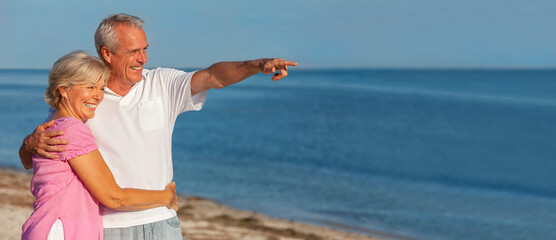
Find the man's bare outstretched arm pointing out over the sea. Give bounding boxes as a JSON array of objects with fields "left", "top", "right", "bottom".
[{"left": 191, "top": 58, "right": 297, "bottom": 95}]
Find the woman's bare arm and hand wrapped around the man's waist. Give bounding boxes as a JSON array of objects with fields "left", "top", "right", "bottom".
[{"left": 69, "top": 150, "right": 177, "bottom": 211}]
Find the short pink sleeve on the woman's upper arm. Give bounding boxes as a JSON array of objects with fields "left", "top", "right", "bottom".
[{"left": 60, "top": 119, "right": 98, "bottom": 161}]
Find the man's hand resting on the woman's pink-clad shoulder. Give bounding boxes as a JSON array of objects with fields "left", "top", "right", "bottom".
[{"left": 23, "top": 121, "right": 68, "bottom": 159}]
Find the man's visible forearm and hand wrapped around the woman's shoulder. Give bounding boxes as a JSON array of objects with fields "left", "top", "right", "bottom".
[{"left": 19, "top": 121, "right": 68, "bottom": 169}]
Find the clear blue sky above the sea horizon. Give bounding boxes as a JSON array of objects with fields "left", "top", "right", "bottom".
[{"left": 0, "top": 0, "right": 556, "bottom": 68}]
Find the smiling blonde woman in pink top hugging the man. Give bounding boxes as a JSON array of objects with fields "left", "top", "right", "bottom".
[{"left": 22, "top": 52, "right": 177, "bottom": 240}]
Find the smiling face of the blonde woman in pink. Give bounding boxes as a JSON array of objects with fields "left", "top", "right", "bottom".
[{"left": 66, "top": 83, "right": 105, "bottom": 121}]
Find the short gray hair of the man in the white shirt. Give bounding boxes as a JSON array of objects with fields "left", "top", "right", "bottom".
[{"left": 95, "top": 13, "right": 144, "bottom": 61}]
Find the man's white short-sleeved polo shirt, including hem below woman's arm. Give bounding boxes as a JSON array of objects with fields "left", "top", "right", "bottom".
[{"left": 86, "top": 68, "right": 206, "bottom": 228}]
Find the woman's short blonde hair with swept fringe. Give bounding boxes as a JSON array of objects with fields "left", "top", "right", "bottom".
[{"left": 44, "top": 51, "right": 110, "bottom": 109}]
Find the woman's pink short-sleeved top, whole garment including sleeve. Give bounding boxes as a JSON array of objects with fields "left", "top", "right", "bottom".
[{"left": 21, "top": 117, "right": 103, "bottom": 240}]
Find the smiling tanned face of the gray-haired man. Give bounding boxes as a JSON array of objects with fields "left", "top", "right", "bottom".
[{"left": 109, "top": 25, "right": 149, "bottom": 85}]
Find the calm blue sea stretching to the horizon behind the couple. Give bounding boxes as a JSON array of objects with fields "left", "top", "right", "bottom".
[{"left": 0, "top": 69, "right": 556, "bottom": 240}]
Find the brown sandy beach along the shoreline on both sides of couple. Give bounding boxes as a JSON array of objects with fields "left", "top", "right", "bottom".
[{"left": 0, "top": 169, "right": 382, "bottom": 240}]
